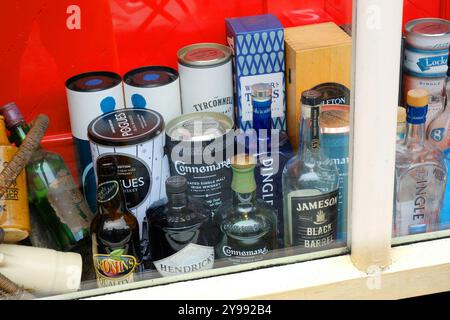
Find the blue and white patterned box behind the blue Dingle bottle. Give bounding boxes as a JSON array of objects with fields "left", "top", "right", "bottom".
[{"left": 226, "top": 14, "right": 286, "bottom": 130}]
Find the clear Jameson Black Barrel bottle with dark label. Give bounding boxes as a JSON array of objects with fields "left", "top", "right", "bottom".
[{"left": 283, "top": 90, "right": 339, "bottom": 248}]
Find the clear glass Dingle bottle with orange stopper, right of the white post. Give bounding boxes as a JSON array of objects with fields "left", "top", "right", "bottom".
[{"left": 393, "top": 89, "right": 447, "bottom": 237}]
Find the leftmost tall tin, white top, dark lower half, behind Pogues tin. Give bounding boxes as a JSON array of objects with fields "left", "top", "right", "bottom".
[{"left": 66, "top": 71, "right": 124, "bottom": 212}]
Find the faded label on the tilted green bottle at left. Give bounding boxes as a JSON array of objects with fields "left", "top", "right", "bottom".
[{"left": 47, "top": 170, "right": 92, "bottom": 234}]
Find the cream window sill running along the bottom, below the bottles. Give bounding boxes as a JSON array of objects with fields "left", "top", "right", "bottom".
[{"left": 67, "top": 239, "right": 450, "bottom": 300}]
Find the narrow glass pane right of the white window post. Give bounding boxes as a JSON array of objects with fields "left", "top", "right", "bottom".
[{"left": 393, "top": 2, "right": 450, "bottom": 244}]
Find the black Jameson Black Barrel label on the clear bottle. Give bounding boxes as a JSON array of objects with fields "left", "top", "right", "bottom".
[{"left": 288, "top": 190, "right": 339, "bottom": 248}]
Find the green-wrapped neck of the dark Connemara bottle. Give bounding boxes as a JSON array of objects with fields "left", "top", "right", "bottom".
[{"left": 231, "top": 166, "right": 256, "bottom": 204}]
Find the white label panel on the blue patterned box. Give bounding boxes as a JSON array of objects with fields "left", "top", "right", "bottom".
[{"left": 239, "top": 72, "right": 284, "bottom": 121}]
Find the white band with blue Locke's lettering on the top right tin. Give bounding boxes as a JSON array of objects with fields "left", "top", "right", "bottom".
[{"left": 403, "top": 46, "right": 448, "bottom": 77}]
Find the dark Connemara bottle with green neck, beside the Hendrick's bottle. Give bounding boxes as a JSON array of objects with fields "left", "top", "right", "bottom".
[{"left": 215, "top": 154, "right": 278, "bottom": 264}]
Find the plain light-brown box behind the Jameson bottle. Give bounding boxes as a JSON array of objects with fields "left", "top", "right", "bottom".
[{"left": 285, "top": 22, "right": 352, "bottom": 149}]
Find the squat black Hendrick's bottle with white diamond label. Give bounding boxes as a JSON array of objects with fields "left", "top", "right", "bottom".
[{"left": 150, "top": 176, "right": 214, "bottom": 276}]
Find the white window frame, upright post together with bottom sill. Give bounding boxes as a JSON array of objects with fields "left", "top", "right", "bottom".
[{"left": 44, "top": 0, "right": 450, "bottom": 300}]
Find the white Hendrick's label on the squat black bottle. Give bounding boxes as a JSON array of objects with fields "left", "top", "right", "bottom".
[{"left": 153, "top": 243, "right": 214, "bottom": 277}]
